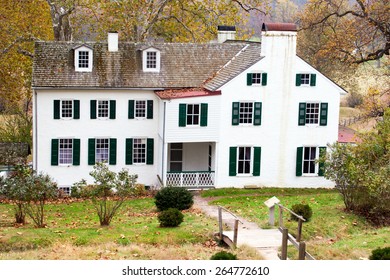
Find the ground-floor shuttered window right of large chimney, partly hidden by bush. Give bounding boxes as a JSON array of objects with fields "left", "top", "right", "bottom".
[{"left": 296, "top": 146, "right": 326, "bottom": 176}]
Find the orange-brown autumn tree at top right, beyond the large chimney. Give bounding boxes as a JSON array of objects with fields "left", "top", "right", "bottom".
[{"left": 300, "top": 0, "right": 390, "bottom": 64}]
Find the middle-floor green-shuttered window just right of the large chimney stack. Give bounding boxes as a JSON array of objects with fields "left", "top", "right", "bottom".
[{"left": 298, "top": 102, "right": 328, "bottom": 126}]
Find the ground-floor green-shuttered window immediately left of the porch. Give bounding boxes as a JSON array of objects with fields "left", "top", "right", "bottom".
[{"left": 125, "top": 138, "right": 154, "bottom": 164}]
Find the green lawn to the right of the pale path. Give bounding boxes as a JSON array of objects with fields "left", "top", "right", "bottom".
[{"left": 202, "top": 188, "right": 390, "bottom": 259}]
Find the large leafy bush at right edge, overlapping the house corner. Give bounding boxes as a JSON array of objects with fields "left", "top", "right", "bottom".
[{"left": 322, "top": 109, "right": 390, "bottom": 224}]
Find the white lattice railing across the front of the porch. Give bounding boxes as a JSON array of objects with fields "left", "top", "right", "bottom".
[{"left": 166, "top": 171, "right": 215, "bottom": 188}]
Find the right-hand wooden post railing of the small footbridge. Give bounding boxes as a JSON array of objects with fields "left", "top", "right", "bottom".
[{"left": 276, "top": 203, "right": 315, "bottom": 260}]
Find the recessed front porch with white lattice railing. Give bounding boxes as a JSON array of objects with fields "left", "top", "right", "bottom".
[{"left": 165, "top": 142, "right": 216, "bottom": 189}]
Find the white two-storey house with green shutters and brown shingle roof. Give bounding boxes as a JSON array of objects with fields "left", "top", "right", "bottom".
[{"left": 33, "top": 24, "right": 345, "bottom": 190}]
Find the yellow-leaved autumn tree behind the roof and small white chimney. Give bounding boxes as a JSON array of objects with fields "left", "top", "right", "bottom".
[{"left": 99, "top": 0, "right": 269, "bottom": 42}]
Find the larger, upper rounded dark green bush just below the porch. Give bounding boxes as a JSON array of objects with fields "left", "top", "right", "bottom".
[{"left": 154, "top": 187, "right": 194, "bottom": 211}]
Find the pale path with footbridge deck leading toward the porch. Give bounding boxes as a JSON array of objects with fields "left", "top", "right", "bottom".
[{"left": 194, "top": 194, "right": 282, "bottom": 260}]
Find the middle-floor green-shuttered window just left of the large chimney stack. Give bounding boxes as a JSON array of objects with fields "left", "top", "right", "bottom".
[{"left": 232, "top": 102, "right": 262, "bottom": 125}]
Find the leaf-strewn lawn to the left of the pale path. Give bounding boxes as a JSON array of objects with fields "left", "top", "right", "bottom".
[{"left": 0, "top": 197, "right": 260, "bottom": 259}]
